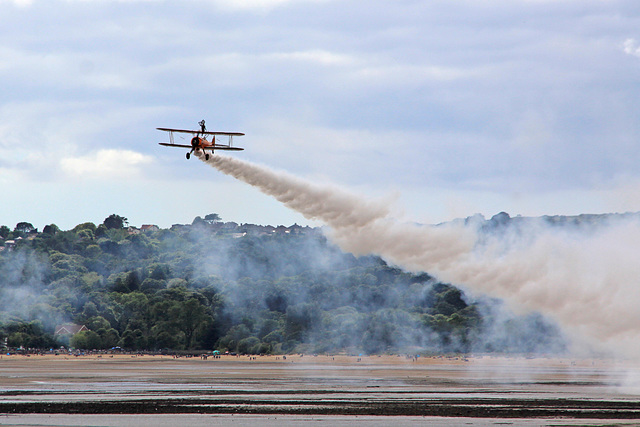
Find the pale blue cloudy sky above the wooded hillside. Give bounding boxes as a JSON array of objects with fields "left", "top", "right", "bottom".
[{"left": 0, "top": 0, "right": 640, "bottom": 229}]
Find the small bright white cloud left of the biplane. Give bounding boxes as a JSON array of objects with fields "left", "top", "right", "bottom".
[{"left": 60, "top": 149, "right": 151, "bottom": 179}]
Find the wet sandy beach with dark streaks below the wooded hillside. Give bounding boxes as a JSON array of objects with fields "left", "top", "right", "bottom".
[{"left": 0, "top": 355, "right": 640, "bottom": 427}]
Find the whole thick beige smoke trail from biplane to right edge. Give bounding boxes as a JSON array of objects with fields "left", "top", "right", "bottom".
[{"left": 202, "top": 156, "right": 640, "bottom": 355}]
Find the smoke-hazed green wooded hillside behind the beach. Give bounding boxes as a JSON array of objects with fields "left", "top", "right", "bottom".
[{"left": 0, "top": 214, "right": 563, "bottom": 354}]
